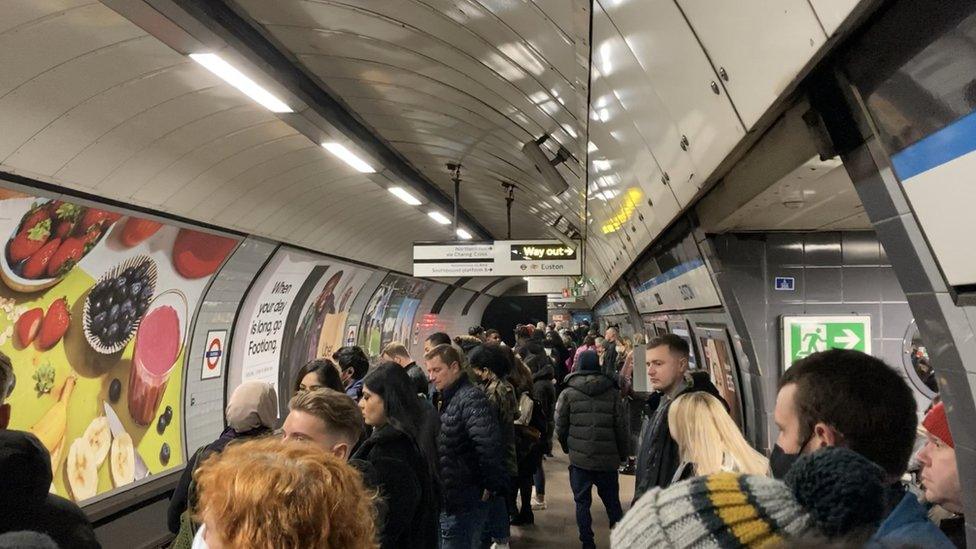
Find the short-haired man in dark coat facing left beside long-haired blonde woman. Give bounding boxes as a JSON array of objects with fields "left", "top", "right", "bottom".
[{"left": 634, "top": 334, "right": 729, "bottom": 501}]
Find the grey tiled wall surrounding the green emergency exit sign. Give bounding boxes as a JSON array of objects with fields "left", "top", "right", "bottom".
[{"left": 709, "top": 232, "right": 928, "bottom": 446}]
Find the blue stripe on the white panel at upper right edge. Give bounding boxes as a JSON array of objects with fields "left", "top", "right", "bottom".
[{"left": 891, "top": 112, "right": 976, "bottom": 182}]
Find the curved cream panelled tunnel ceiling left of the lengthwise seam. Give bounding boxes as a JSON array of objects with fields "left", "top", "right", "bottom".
[{"left": 0, "top": 0, "right": 588, "bottom": 272}]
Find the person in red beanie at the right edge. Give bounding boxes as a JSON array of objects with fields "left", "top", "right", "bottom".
[{"left": 918, "top": 402, "right": 966, "bottom": 548}]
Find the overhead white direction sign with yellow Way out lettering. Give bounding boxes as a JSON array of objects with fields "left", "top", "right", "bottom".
[{"left": 413, "top": 240, "right": 582, "bottom": 277}]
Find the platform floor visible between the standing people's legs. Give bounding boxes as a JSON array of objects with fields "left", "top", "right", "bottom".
[{"left": 511, "top": 454, "right": 634, "bottom": 549}]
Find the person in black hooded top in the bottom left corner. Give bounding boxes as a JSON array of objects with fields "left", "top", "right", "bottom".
[{"left": 0, "top": 430, "right": 101, "bottom": 549}]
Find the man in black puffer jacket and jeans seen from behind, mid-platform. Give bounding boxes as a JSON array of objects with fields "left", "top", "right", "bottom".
[{"left": 556, "top": 351, "right": 627, "bottom": 549}]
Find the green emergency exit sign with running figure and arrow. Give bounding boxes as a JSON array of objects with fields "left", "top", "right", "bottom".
[{"left": 782, "top": 315, "right": 871, "bottom": 370}]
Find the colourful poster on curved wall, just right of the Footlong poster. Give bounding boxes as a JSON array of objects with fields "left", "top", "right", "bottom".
[{"left": 360, "top": 274, "right": 430, "bottom": 358}]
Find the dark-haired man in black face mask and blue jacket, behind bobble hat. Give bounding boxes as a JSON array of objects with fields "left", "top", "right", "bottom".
[{"left": 770, "top": 349, "right": 952, "bottom": 549}]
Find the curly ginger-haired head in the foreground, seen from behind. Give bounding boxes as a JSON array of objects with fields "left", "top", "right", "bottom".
[{"left": 192, "top": 436, "right": 379, "bottom": 549}]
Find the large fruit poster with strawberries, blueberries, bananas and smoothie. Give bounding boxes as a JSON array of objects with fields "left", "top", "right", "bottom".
[{"left": 0, "top": 191, "right": 237, "bottom": 504}]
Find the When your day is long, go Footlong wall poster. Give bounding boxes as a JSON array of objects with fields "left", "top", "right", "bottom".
[{"left": 230, "top": 248, "right": 371, "bottom": 406}]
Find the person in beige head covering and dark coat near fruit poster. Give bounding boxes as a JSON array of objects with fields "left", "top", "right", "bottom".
[{"left": 167, "top": 381, "right": 278, "bottom": 547}]
